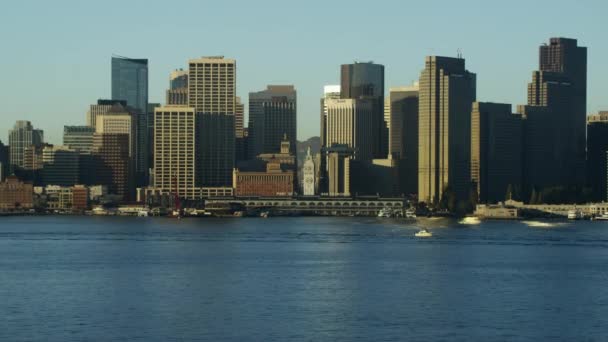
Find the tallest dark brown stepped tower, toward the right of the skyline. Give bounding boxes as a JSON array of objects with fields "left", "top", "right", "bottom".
[{"left": 524, "top": 38, "right": 587, "bottom": 190}]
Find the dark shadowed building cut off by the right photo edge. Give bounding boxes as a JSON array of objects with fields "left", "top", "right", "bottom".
[{"left": 587, "top": 112, "right": 608, "bottom": 201}]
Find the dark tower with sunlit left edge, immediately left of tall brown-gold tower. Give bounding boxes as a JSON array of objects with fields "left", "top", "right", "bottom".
[{"left": 385, "top": 83, "right": 419, "bottom": 195}]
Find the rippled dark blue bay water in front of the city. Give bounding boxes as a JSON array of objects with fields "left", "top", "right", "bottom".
[{"left": 0, "top": 217, "right": 608, "bottom": 341}]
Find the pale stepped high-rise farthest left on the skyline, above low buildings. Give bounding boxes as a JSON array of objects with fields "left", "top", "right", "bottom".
[{"left": 8, "top": 121, "right": 44, "bottom": 172}]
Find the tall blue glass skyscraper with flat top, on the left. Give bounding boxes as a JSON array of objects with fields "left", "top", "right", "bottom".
[{"left": 112, "top": 56, "right": 150, "bottom": 185}]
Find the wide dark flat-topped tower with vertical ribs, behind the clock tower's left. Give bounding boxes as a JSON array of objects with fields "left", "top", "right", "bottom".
[{"left": 249, "top": 85, "right": 297, "bottom": 159}]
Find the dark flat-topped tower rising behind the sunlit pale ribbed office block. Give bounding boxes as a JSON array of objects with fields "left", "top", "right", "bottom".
[{"left": 340, "top": 62, "right": 388, "bottom": 159}]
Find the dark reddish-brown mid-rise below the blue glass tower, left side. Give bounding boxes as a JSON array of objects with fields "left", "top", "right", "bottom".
[{"left": 93, "top": 133, "right": 133, "bottom": 201}]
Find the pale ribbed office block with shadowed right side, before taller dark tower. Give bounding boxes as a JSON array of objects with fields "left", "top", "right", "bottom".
[{"left": 325, "top": 99, "right": 375, "bottom": 161}]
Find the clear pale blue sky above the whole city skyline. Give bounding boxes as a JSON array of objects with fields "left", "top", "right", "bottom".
[{"left": 0, "top": 0, "right": 608, "bottom": 143}]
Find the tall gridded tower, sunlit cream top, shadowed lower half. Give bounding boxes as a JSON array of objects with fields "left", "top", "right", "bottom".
[{"left": 188, "top": 56, "right": 236, "bottom": 187}]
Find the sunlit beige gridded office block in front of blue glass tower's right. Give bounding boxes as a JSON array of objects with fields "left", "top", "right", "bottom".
[{"left": 154, "top": 106, "right": 200, "bottom": 199}]
